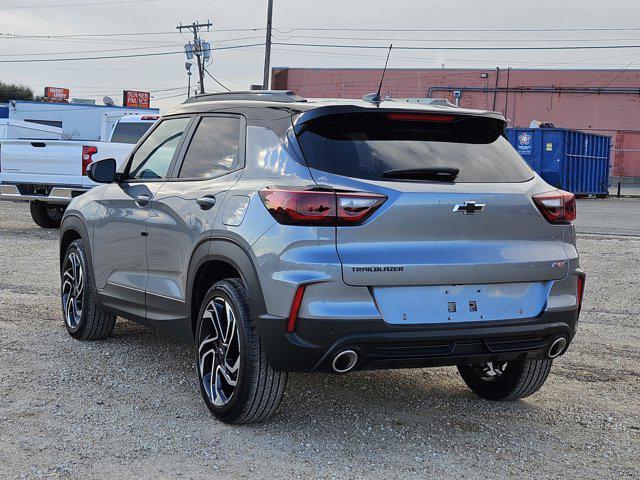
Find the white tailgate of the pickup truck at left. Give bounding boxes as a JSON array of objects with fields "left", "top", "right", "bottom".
[{"left": 0, "top": 140, "right": 82, "bottom": 185}]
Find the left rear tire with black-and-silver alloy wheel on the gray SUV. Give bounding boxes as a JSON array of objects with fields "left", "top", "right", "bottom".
[{"left": 195, "top": 279, "right": 287, "bottom": 424}]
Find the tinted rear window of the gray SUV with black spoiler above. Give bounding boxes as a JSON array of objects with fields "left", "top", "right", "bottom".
[{"left": 298, "top": 112, "right": 533, "bottom": 183}]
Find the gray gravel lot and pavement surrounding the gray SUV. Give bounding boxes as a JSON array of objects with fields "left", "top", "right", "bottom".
[{"left": 0, "top": 199, "right": 640, "bottom": 479}]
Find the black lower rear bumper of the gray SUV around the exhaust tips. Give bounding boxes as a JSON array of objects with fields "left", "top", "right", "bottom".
[{"left": 258, "top": 309, "right": 578, "bottom": 372}]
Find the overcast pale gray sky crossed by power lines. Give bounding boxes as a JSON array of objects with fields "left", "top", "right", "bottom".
[{"left": 0, "top": 0, "right": 640, "bottom": 109}]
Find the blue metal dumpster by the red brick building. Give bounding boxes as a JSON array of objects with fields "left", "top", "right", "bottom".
[{"left": 507, "top": 128, "right": 611, "bottom": 196}]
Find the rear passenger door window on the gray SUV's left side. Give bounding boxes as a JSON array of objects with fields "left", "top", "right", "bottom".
[{"left": 178, "top": 117, "right": 240, "bottom": 178}]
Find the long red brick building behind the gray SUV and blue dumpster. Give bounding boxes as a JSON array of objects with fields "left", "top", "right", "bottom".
[{"left": 272, "top": 68, "right": 640, "bottom": 177}]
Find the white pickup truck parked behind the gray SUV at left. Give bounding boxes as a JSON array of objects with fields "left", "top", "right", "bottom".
[{"left": 0, "top": 115, "right": 158, "bottom": 228}]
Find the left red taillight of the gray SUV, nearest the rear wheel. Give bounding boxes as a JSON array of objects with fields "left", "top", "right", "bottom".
[{"left": 259, "top": 188, "right": 387, "bottom": 226}]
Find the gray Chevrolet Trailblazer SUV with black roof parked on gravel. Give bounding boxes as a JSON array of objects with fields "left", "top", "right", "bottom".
[{"left": 60, "top": 91, "right": 584, "bottom": 423}]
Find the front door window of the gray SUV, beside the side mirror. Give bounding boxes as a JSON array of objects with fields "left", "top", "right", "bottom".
[{"left": 128, "top": 117, "right": 191, "bottom": 179}]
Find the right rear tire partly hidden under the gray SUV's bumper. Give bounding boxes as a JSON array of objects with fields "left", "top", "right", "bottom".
[{"left": 458, "top": 358, "right": 553, "bottom": 401}]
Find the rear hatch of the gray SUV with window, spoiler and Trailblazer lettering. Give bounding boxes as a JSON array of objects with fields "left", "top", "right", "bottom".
[{"left": 298, "top": 111, "right": 568, "bottom": 323}]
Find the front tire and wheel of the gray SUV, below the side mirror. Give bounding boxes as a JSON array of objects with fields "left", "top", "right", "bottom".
[{"left": 60, "top": 240, "right": 116, "bottom": 340}]
